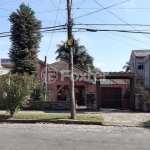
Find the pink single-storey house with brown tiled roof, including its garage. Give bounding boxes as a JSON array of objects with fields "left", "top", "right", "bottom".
[{"left": 0, "top": 57, "right": 130, "bottom": 108}]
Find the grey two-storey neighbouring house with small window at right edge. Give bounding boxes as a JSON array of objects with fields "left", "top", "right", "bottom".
[{"left": 130, "top": 50, "right": 150, "bottom": 87}]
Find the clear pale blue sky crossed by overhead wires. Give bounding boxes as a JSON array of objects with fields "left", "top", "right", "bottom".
[{"left": 0, "top": 0, "right": 150, "bottom": 72}]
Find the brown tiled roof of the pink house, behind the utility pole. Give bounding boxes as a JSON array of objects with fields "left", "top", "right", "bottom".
[{"left": 49, "top": 60, "right": 91, "bottom": 75}]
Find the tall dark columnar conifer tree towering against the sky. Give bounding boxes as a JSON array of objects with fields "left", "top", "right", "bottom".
[{"left": 9, "top": 3, "right": 41, "bottom": 75}]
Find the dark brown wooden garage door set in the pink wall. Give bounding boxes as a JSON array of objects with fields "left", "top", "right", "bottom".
[{"left": 101, "top": 87, "right": 121, "bottom": 108}]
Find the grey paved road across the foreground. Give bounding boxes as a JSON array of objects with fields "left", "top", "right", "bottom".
[{"left": 0, "top": 124, "right": 150, "bottom": 150}]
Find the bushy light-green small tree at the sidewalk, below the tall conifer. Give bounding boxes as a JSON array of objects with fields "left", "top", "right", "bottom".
[{"left": 0, "top": 73, "right": 39, "bottom": 116}]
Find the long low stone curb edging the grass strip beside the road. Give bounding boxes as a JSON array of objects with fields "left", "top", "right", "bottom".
[{"left": 0, "top": 119, "right": 103, "bottom": 125}]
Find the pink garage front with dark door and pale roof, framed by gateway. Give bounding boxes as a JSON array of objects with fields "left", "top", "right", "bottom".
[{"left": 101, "top": 79, "right": 130, "bottom": 109}]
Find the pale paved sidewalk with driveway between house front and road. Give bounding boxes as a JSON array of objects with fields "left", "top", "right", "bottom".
[{"left": 0, "top": 109, "right": 150, "bottom": 127}]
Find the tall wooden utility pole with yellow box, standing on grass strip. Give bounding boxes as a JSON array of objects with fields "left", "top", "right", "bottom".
[{"left": 67, "top": 0, "right": 76, "bottom": 119}]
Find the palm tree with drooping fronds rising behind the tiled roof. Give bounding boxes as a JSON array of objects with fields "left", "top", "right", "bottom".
[{"left": 55, "top": 39, "right": 94, "bottom": 70}]
